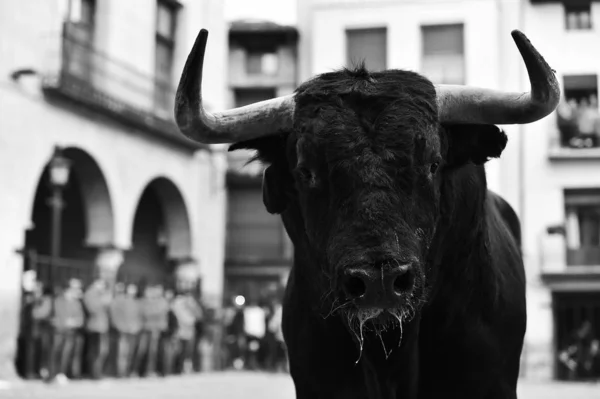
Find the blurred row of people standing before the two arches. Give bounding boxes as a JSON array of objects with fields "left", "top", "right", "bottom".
[{"left": 17, "top": 279, "right": 204, "bottom": 383}]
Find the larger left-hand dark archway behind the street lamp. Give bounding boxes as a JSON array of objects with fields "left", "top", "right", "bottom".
[{"left": 15, "top": 148, "right": 114, "bottom": 376}]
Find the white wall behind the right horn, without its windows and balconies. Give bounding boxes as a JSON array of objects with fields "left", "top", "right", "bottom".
[{"left": 298, "top": 0, "right": 600, "bottom": 378}]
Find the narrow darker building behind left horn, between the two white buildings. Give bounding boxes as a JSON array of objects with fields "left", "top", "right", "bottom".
[{"left": 225, "top": 20, "right": 298, "bottom": 301}]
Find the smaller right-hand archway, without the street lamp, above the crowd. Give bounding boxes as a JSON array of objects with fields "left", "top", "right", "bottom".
[{"left": 120, "top": 177, "right": 192, "bottom": 283}]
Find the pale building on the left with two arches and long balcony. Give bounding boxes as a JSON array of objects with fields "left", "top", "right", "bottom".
[{"left": 0, "top": 0, "right": 227, "bottom": 379}]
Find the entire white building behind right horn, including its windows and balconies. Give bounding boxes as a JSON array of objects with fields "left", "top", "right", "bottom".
[{"left": 298, "top": 0, "right": 600, "bottom": 379}]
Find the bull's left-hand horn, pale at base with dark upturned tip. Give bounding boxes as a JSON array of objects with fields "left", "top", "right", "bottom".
[{"left": 175, "top": 29, "right": 295, "bottom": 144}]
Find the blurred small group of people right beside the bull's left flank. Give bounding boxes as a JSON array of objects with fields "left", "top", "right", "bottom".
[{"left": 223, "top": 296, "right": 288, "bottom": 372}]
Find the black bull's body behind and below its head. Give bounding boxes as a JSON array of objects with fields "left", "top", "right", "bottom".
[{"left": 283, "top": 170, "right": 526, "bottom": 399}]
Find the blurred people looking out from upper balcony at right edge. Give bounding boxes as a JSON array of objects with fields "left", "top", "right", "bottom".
[{"left": 557, "top": 94, "right": 600, "bottom": 148}]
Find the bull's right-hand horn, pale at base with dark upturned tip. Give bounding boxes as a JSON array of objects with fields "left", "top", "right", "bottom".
[{"left": 436, "top": 30, "right": 560, "bottom": 125}]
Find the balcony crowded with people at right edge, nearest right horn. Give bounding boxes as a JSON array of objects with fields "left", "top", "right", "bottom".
[{"left": 549, "top": 95, "right": 600, "bottom": 160}]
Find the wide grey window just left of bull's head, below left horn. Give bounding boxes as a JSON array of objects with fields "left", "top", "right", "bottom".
[{"left": 227, "top": 185, "right": 285, "bottom": 262}]
